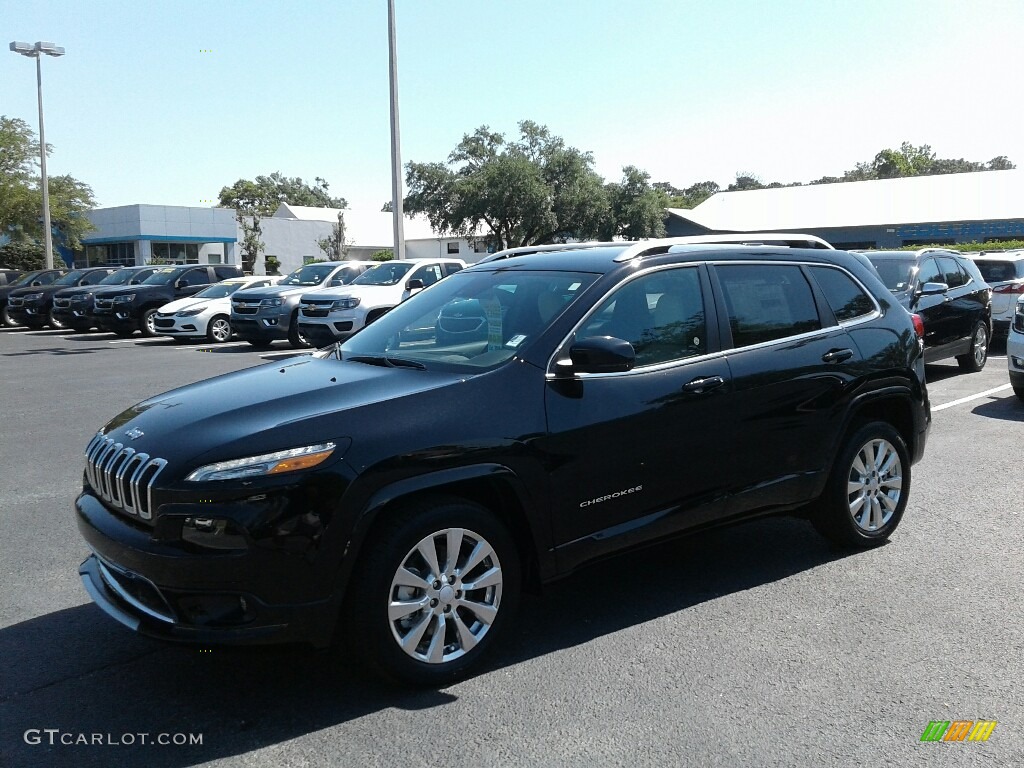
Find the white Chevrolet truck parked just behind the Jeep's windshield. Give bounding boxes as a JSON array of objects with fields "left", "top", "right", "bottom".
[{"left": 299, "top": 259, "right": 466, "bottom": 347}]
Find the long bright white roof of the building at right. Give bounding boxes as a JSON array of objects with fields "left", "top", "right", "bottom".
[{"left": 668, "top": 170, "right": 1024, "bottom": 232}]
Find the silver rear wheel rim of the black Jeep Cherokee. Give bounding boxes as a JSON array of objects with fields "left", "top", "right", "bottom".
[{"left": 847, "top": 438, "right": 903, "bottom": 532}]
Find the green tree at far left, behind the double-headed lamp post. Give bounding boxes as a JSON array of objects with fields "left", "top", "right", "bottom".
[{"left": 0, "top": 117, "right": 96, "bottom": 256}]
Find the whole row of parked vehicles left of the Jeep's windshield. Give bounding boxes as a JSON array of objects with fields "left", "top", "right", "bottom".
[{"left": 0, "top": 259, "right": 465, "bottom": 348}]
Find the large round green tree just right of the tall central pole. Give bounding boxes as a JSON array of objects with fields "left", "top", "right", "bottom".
[{"left": 404, "top": 120, "right": 664, "bottom": 250}]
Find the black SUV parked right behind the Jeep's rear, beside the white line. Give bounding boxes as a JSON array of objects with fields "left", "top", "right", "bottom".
[{"left": 864, "top": 248, "right": 992, "bottom": 372}]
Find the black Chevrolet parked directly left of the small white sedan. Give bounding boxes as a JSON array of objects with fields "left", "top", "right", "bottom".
[{"left": 93, "top": 264, "right": 242, "bottom": 337}]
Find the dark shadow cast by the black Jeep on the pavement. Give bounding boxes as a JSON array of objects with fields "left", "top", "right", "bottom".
[{"left": 0, "top": 518, "right": 844, "bottom": 768}]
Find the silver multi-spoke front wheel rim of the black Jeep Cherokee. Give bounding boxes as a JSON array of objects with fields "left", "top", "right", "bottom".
[{"left": 387, "top": 527, "right": 504, "bottom": 665}]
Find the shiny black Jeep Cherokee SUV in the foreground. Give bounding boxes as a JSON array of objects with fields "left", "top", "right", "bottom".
[{"left": 75, "top": 236, "right": 931, "bottom": 684}]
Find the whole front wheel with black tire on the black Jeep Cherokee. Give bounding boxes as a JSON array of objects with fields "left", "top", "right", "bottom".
[{"left": 340, "top": 498, "right": 520, "bottom": 686}]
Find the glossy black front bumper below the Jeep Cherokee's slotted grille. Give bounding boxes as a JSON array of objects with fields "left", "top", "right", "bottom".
[{"left": 75, "top": 493, "right": 337, "bottom": 647}]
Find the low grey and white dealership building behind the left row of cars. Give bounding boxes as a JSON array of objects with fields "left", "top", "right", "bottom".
[{"left": 77, "top": 203, "right": 485, "bottom": 273}]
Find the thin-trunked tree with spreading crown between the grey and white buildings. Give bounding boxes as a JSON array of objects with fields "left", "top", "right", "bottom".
[{"left": 219, "top": 171, "right": 348, "bottom": 272}]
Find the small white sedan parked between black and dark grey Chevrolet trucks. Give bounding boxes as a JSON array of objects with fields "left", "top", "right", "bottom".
[{"left": 153, "top": 275, "right": 281, "bottom": 344}]
